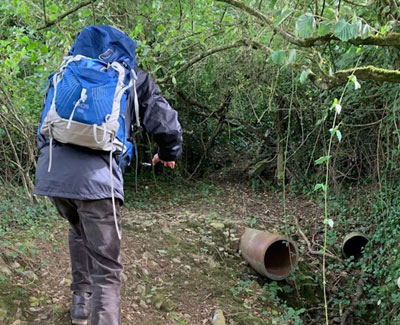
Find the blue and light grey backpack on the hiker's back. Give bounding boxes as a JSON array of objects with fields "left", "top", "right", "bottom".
[{"left": 38, "top": 26, "right": 140, "bottom": 171}]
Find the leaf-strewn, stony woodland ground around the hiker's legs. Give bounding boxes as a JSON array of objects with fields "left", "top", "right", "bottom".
[{"left": 0, "top": 178, "right": 319, "bottom": 325}]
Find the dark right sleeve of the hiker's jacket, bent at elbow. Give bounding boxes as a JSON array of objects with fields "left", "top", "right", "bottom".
[{"left": 135, "top": 69, "right": 182, "bottom": 161}]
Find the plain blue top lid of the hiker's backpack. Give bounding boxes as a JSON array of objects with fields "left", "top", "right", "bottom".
[{"left": 69, "top": 25, "right": 136, "bottom": 69}]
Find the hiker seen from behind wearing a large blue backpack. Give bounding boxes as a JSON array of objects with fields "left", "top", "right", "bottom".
[{"left": 34, "top": 26, "right": 182, "bottom": 325}]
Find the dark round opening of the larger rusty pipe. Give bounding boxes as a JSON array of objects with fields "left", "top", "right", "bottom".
[{"left": 264, "top": 240, "right": 297, "bottom": 276}]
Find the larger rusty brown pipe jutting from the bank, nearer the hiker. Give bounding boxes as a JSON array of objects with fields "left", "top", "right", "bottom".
[{"left": 239, "top": 228, "right": 299, "bottom": 280}]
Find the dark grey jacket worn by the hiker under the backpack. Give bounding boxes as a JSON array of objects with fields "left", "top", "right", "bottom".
[{"left": 34, "top": 69, "right": 182, "bottom": 201}]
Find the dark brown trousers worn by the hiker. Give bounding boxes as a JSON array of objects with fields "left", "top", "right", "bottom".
[{"left": 50, "top": 197, "right": 122, "bottom": 325}]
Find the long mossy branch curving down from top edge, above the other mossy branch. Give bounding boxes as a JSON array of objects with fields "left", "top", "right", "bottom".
[{"left": 218, "top": 0, "right": 400, "bottom": 47}]
